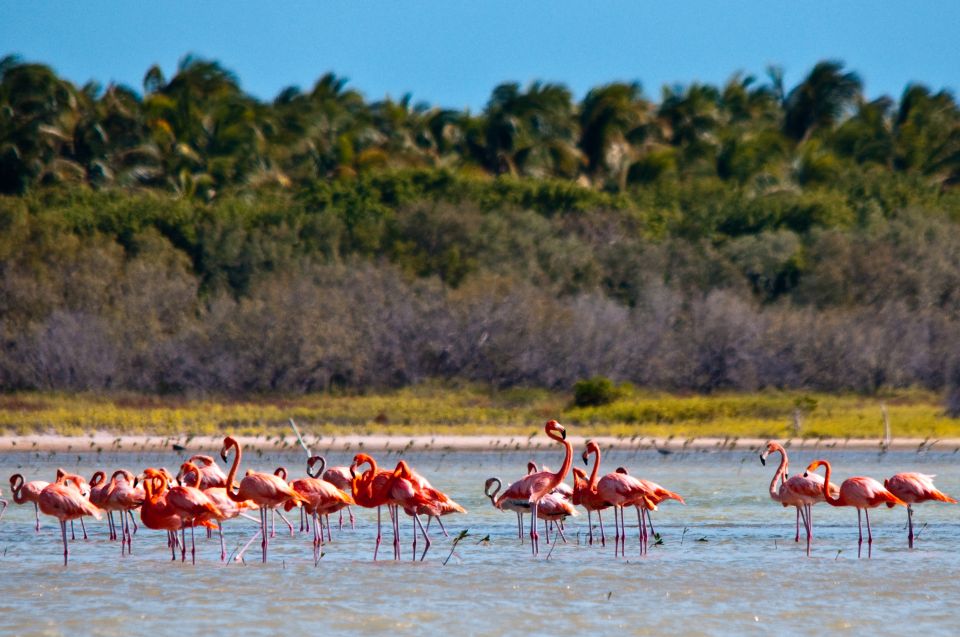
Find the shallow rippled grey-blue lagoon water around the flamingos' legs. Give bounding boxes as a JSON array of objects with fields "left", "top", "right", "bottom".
[{"left": 0, "top": 450, "right": 960, "bottom": 635}]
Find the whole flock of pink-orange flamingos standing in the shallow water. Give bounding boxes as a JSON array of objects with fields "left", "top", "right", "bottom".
[{"left": 0, "top": 420, "right": 956, "bottom": 566}]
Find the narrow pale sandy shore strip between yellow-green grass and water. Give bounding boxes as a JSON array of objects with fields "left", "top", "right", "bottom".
[{"left": 0, "top": 432, "right": 960, "bottom": 454}]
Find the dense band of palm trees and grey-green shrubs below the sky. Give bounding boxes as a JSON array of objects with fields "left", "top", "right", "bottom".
[{"left": 0, "top": 57, "right": 960, "bottom": 402}]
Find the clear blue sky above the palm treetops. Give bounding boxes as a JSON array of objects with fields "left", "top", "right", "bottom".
[{"left": 0, "top": 0, "right": 960, "bottom": 111}]
